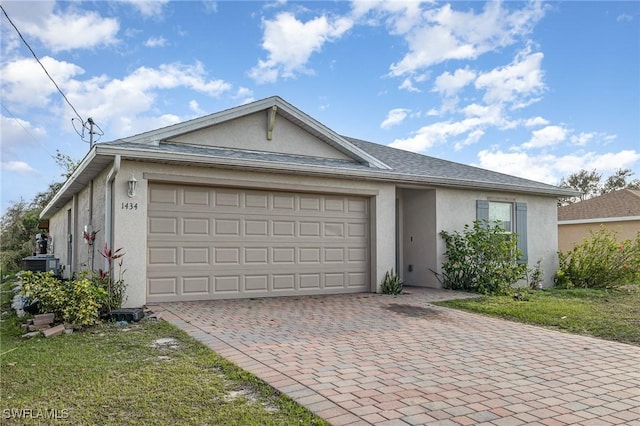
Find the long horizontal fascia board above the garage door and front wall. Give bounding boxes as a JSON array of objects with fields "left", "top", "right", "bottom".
[{"left": 96, "top": 145, "right": 573, "bottom": 197}]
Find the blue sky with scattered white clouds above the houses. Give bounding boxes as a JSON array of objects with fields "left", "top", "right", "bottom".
[{"left": 0, "top": 0, "right": 640, "bottom": 211}]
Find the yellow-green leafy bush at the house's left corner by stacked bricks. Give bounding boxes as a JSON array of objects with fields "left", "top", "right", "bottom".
[{"left": 20, "top": 271, "right": 107, "bottom": 326}]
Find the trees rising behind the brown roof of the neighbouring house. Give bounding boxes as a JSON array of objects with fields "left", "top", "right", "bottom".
[{"left": 558, "top": 169, "right": 640, "bottom": 205}]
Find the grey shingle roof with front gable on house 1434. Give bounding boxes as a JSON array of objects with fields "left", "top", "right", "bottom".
[{"left": 41, "top": 96, "right": 576, "bottom": 218}]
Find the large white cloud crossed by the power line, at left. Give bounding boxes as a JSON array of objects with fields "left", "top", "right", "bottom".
[{"left": 1, "top": 57, "right": 232, "bottom": 139}]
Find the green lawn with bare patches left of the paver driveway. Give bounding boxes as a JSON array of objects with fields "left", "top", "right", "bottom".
[{"left": 0, "top": 280, "right": 327, "bottom": 425}]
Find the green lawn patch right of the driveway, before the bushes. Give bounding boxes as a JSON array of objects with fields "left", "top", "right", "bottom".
[{"left": 436, "top": 286, "right": 640, "bottom": 345}]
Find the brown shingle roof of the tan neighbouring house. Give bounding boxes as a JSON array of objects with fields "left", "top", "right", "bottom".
[{"left": 558, "top": 189, "right": 640, "bottom": 220}]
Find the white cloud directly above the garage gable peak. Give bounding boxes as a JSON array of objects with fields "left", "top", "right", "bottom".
[{"left": 249, "top": 12, "right": 353, "bottom": 83}]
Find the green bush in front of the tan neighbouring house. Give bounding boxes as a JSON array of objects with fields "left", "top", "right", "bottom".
[{"left": 555, "top": 226, "right": 640, "bottom": 288}]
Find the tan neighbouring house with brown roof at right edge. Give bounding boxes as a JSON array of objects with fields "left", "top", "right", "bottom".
[{"left": 558, "top": 189, "right": 640, "bottom": 251}]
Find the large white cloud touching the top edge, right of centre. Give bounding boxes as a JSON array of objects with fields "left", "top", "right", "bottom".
[{"left": 385, "top": 1, "right": 544, "bottom": 76}]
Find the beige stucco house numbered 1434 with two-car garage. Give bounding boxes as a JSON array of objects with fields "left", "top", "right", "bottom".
[{"left": 41, "top": 97, "right": 575, "bottom": 306}]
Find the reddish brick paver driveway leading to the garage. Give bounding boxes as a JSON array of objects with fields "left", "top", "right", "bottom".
[{"left": 152, "top": 289, "right": 640, "bottom": 426}]
